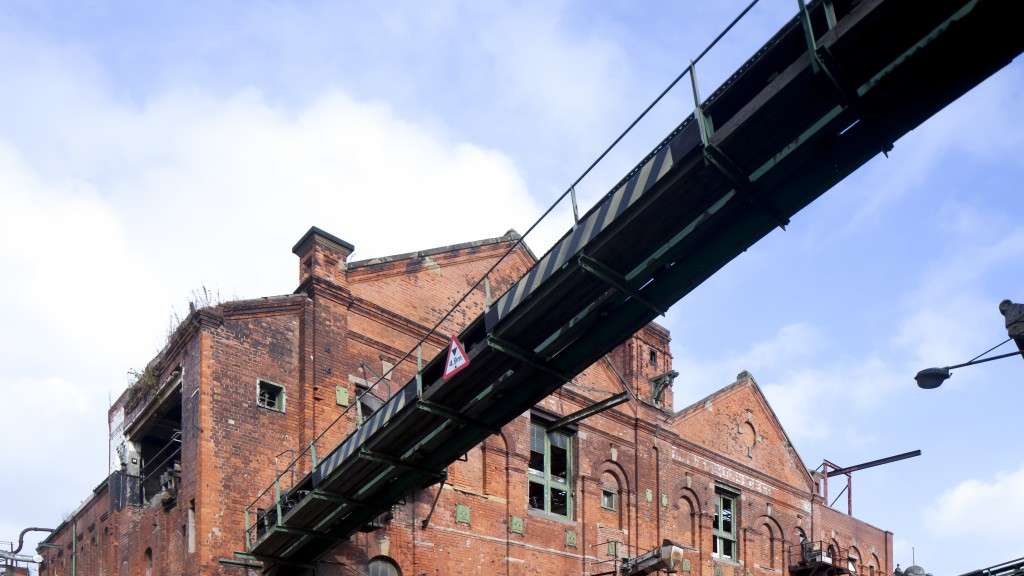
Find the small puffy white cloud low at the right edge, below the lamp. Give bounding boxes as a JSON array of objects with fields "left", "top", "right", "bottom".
[{"left": 925, "top": 464, "right": 1024, "bottom": 541}]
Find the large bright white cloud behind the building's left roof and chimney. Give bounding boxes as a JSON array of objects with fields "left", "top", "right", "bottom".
[{"left": 0, "top": 36, "right": 539, "bottom": 525}]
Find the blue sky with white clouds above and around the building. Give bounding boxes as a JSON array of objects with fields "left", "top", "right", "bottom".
[{"left": 0, "top": 0, "right": 1024, "bottom": 575}]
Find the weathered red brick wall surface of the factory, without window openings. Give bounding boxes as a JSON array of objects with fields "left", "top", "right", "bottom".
[{"left": 44, "top": 228, "right": 892, "bottom": 576}]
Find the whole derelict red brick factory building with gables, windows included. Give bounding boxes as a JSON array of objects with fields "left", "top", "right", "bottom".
[{"left": 39, "top": 229, "right": 893, "bottom": 576}]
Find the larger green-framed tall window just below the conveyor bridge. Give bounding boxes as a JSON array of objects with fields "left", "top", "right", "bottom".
[{"left": 527, "top": 422, "right": 572, "bottom": 518}]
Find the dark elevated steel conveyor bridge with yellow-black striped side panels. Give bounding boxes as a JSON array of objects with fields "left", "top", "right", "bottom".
[{"left": 246, "top": 0, "right": 1024, "bottom": 572}]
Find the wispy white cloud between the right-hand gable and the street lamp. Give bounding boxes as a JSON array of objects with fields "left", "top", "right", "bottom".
[{"left": 674, "top": 228, "right": 1024, "bottom": 444}]
